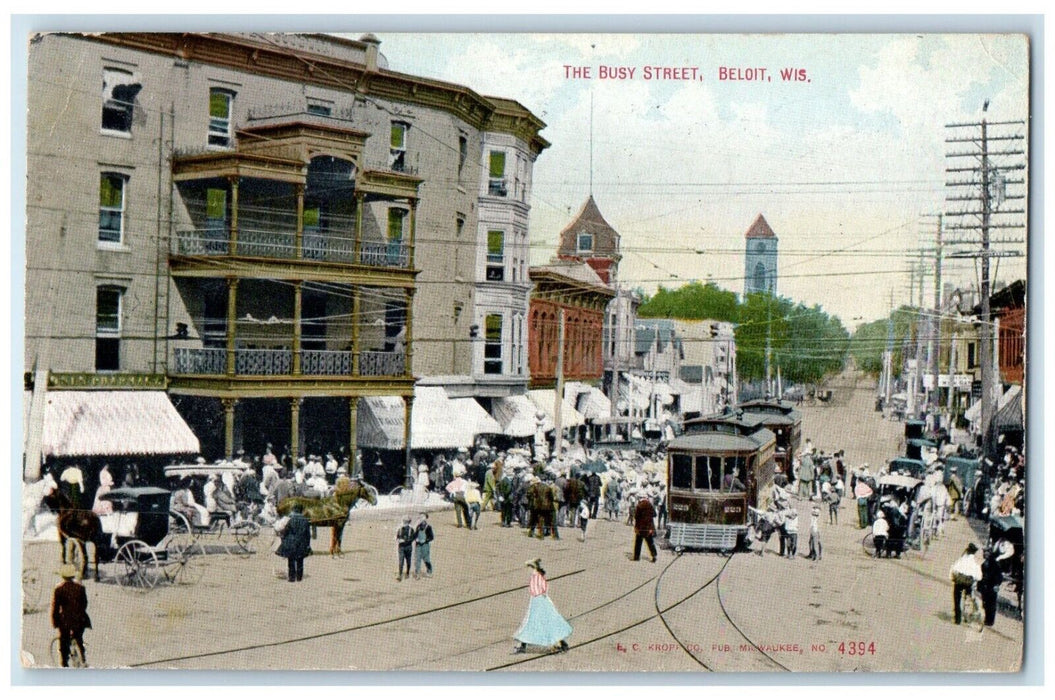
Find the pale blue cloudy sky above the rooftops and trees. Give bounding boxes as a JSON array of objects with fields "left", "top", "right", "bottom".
[{"left": 367, "top": 33, "right": 1030, "bottom": 328}]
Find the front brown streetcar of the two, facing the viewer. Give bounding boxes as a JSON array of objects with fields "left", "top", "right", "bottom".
[{"left": 667, "top": 412, "right": 776, "bottom": 551}]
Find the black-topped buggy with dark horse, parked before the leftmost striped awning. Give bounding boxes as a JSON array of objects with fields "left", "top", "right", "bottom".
[{"left": 47, "top": 486, "right": 204, "bottom": 590}]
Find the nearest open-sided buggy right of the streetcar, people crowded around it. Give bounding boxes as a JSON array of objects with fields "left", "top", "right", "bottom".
[{"left": 862, "top": 473, "right": 933, "bottom": 559}]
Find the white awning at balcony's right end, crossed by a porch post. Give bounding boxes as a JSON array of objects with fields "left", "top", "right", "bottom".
[{"left": 357, "top": 387, "right": 483, "bottom": 450}]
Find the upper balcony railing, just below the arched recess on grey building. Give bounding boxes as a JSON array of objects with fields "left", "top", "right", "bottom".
[{"left": 172, "top": 229, "right": 410, "bottom": 268}]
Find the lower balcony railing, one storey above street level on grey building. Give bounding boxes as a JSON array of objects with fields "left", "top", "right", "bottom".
[{"left": 172, "top": 348, "right": 406, "bottom": 376}]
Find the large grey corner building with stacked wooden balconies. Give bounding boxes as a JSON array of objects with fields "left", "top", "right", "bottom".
[{"left": 24, "top": 34, "right": 549, "bottom": 472}]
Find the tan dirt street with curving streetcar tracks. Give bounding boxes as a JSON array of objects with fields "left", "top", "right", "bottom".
[{"left": 22, "top": 371, "right": 1022, "bottom": 672}]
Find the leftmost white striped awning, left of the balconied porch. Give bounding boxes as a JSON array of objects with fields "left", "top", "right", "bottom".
[{"left": 35, "top": 391, "right": 202, "bottom": 456}]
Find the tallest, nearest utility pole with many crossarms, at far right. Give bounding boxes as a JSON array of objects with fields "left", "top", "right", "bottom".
[{"left": 945, "top": 100, "right": 1025, "bottom": 453}]
